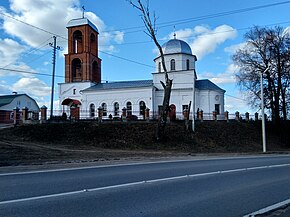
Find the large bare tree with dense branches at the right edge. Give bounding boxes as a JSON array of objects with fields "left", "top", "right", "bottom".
[{"left": 233, "top": 26, "right": 290, "bottom": 124}]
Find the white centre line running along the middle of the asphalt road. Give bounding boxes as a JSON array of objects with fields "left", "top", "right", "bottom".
[{"left": 0, "top": 164, "right": 290, "bottom": 205}]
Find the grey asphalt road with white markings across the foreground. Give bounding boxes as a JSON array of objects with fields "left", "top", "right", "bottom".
[{"left": 0, "top": 156, "right": 290, "bottom": 217}]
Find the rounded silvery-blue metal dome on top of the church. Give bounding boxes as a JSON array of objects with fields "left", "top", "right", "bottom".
[{"left": 162, "top": 39, "right": 192, "bottom": 55}]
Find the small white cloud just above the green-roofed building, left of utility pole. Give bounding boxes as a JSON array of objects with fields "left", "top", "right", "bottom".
[{"left": 12, "top": 78, "right": 51, "bottom": 97}]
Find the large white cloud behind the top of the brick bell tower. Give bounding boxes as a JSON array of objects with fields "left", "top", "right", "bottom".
[{"left": 2, "top": 0, "right": 124, "bottom": 50}]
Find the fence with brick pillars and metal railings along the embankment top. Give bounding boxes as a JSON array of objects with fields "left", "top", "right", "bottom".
[{"left": 0, "top": 107, "right": 268, "bottom": 124}]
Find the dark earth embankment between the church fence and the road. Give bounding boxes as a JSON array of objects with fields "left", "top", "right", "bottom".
[{"left": 0, "top": 122, "right": 289, "bottom": 170}]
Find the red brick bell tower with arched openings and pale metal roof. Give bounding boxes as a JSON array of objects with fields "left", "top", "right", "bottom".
[{"left": 65, "top": 18, "right": 101, "bottom": 83}]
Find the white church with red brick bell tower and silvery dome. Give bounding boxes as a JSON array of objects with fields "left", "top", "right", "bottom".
[{"left": 59, "top": 18, "right": 225, "bottom": 119}]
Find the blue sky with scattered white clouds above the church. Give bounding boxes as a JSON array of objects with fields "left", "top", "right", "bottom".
[{"left": 0, "top": 0, "right": 290, "bottom": 113}]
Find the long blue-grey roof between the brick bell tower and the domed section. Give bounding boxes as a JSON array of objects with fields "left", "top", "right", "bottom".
[{"left": 83, "top": 80, "right": 153, "bottom": 92}]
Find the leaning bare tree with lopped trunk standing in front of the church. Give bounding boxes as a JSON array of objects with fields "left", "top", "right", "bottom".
[{"left": 128, "top": 0, "right": 172, "bottom": 141}]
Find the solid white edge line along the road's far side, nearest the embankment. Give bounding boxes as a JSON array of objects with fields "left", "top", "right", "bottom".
[{"left": 0, "top": 154, "right": 290, "bottom": 177}]
